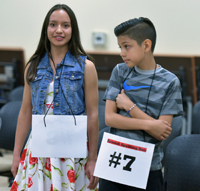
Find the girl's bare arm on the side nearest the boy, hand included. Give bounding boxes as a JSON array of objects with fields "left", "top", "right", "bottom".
[{"left": 84, "top": 60, "right": 99, "bottom": 189}]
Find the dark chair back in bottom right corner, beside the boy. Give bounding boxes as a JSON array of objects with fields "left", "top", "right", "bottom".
[{"left": 164, "top": 134, "right": 200, "bottom": 191}]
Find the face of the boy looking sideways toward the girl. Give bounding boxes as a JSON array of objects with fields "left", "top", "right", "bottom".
[{"left": 117, "top": 35, "right": 145, "bottom": 69}]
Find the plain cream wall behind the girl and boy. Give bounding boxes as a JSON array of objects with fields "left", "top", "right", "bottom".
[{"left": 0, "top": 0, "right": 200, "bottom": 61}]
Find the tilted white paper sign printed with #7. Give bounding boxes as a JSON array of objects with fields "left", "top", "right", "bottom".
[{"left": 94, "top": 133, "right": 155, "bottom": 189}]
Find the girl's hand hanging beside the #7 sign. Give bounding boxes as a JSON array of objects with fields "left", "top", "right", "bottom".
[{"left": 85, "top": 160, "right": 99, "bottom": 190}]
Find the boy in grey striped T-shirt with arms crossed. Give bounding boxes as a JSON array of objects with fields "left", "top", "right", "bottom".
[{"left": 99, "top": 17, "right": 183, "bottom": 191}]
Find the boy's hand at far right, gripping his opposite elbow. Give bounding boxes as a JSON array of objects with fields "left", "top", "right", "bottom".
[{"left": 146, "top": 120, "right": 172, "bottom": 141}]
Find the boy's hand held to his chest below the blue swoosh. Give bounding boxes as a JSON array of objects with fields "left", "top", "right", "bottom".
[{"left": 116, "top": 89, "right": 133, "bottom": 110}]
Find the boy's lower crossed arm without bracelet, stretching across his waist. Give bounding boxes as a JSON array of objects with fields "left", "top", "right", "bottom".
[{"left": 105, "top": 99, "right": 172, "bottom": 140}]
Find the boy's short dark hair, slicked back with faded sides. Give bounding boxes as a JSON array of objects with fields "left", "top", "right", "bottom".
[{"left": 114, "top": 17, "right": 156, "bottom": 52}]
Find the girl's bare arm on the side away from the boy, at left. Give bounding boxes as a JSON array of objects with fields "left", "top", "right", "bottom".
[{"left": 11, "top": 67, "right": 32, "bottom": 177}]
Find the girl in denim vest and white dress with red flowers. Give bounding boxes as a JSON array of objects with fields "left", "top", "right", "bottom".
[{"left": 11, "top": 4, "right": 98, "bottom": 191}]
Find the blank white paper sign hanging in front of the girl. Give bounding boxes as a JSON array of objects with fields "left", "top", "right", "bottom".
[{"left": 31, "top": 115, "right": 87, "bottom": 158}]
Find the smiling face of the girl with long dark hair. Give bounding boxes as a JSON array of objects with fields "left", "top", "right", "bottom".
[{"left": 47, "top": 9, "right": 72, "bottom": 49}]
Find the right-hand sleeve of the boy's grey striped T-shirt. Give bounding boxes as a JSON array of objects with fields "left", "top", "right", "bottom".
[{"left": 160, "top": 78, "right": 183, "bottom": 117}]
